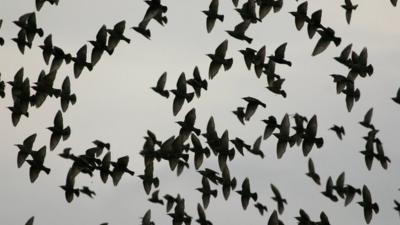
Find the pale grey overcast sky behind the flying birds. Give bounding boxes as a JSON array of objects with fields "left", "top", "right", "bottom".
[{"left": 0, "top": 0, "right": 400, "bottom": 225}]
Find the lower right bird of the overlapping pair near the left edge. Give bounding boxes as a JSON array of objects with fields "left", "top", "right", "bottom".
[{"left": 26, "top": 146, "right": 50, "bottom": 183}]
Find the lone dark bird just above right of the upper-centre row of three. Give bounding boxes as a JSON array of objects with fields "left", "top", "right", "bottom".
[{"left": 207, "top": 40, "right": 233, "bottom": 79}]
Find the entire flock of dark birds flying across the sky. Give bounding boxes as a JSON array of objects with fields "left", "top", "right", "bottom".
[{"left": 0, "top": 0, "right": 400, "bottom": 225}]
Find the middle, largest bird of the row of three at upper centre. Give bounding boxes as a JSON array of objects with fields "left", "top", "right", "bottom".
[{"left": 171, "top": 73, "right": 194, "bottom": 116}]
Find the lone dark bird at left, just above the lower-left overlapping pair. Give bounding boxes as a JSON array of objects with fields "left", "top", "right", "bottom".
[{"left": 47, "top": 111, "right": 71, "bottom": 151}]
